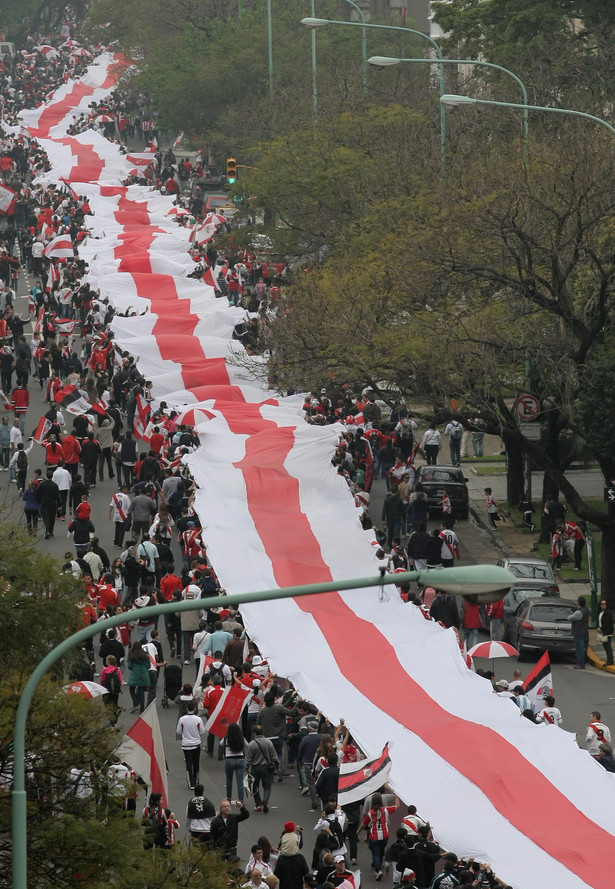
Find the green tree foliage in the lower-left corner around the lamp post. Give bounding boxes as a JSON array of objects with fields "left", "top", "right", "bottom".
[{"left": 0, "top": 523, "right": 226, "bottom": 889}]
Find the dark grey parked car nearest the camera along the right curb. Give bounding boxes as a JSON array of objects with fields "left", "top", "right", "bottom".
[{"left": 509, "top": 597, "right": 577, "bottom": 661}]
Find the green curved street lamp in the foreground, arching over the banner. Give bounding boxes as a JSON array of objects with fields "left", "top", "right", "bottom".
[{"left": 12, "top": 565, "right": 515, "bottom": 889}]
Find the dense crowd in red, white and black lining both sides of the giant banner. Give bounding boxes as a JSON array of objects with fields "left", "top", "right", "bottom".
[{"left": 0, "top": 13, "right": 615, "bottom": 889}]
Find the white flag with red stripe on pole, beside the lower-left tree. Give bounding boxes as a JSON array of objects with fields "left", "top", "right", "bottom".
[{"left": 115, "top": 701, "right": 169, "bottom": 808}]
